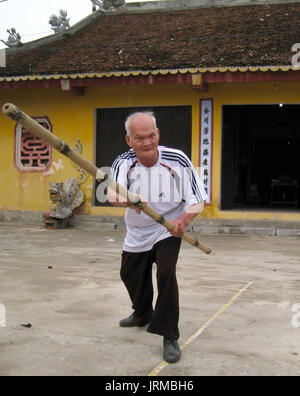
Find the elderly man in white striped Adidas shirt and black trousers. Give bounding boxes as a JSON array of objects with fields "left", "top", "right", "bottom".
[{"left": 107, "top": 112, "right": 206, "bottom": 363}]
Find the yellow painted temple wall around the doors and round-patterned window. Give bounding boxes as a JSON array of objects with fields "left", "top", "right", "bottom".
[{"left": 0, "top": 82, "right": 300, "bottom": 221}]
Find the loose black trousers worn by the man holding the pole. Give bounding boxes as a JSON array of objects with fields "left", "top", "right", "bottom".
[{"left": 120, "top": 237, "right": 181, "bottom": 340}]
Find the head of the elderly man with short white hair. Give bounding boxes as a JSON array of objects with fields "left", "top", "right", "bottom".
[{"left": 126, "top": 115, "right": 159, "bottom": 166}]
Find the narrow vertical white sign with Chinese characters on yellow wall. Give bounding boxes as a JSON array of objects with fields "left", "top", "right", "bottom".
[{"left": 200, "top": 99, "right": 213, "bottom": 203}]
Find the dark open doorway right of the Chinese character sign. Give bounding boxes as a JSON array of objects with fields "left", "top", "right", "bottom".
[{"left": 221, "top": 104, "right": 300, "bottom": 210}]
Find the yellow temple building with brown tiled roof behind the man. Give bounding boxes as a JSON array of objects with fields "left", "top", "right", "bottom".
[{"left": 0, "top": 0, "right": 300, "bottom": 221}]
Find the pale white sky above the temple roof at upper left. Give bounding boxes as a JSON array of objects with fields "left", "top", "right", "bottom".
[{"left": 0, "top": 0, "right": 162, "bottom": 49}]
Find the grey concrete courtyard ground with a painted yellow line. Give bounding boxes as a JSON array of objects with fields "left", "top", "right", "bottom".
[{"left": 0, "top": 223, "right": 300, "bottom": 376}]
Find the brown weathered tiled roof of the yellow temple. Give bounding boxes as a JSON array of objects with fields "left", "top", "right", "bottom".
[{"left": 0, "top": 3, "right": 300, "bottom": 81}]
